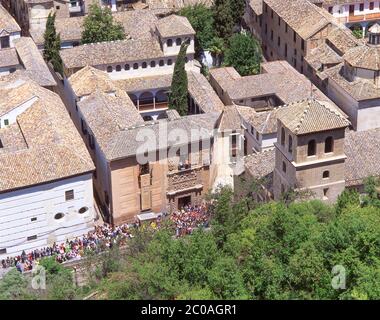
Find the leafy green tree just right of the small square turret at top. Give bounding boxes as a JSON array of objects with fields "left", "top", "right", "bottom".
[{"left": 179, "top": 3, "right": 216, "bottom": 57}]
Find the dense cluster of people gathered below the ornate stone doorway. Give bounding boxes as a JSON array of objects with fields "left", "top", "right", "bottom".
[{"left": 170, "top": 205, "right": 210, "bottom": 237}]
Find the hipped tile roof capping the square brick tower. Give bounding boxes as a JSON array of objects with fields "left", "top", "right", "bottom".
[{"left": 278, "top": 99, "right": 350, "bottom": 135}]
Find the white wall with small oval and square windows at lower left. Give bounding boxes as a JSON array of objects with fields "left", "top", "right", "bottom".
[{"left": 0, "top": 173, "right": 95, "bottom": 259}]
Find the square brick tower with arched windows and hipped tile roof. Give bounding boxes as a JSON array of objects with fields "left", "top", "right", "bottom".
[{"left": 273, "top": 99, "right": 349, "bottom": 202}]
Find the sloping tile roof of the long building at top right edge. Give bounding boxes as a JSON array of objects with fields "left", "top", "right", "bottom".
[{"left": 264, "top": 0, "right": 330, "bottom": 40}]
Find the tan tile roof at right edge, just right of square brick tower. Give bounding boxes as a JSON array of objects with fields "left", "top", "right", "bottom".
[{"left": 344, "top": 129, "right": 380, "bottom": 185}]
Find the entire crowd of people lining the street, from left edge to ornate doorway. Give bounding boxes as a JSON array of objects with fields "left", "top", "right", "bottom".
[{"left": 1, "top": 205, "right": 210, "bottom": 272}]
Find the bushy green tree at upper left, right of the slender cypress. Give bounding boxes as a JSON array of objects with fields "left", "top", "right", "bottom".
[{"left": 82, "top": 4, "right": 125, "bottom": 44}]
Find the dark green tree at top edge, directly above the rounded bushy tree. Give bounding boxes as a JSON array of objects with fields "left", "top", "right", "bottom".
[{"left": 212, "top": 0, "right": 234, "bottom": 41}]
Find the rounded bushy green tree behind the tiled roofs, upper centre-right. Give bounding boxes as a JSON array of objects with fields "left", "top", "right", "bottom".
[{"left": 224, "top": 34, "right": 262, "bottom": 76}]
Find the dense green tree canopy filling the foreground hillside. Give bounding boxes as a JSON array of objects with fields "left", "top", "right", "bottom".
[{"left": 0, "top": 179, "right": 380, "bottom": 299}]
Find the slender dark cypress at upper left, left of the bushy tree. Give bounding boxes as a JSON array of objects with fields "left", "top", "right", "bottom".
[{"left": 44, "top": 13, "right": 63, "bottom": 75}]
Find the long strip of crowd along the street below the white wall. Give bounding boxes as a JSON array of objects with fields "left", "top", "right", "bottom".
[{"left": 1, "top": 224, "right": 136, "bottom": 272}]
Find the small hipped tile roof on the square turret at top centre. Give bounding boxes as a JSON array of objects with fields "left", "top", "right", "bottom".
[{"left": 156, "top": 14, "right": 195, "bottom": 38}]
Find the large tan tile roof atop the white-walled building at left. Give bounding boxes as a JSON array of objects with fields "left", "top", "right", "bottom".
[{"left": 0, "top": 72, "right": 94, "bottom": 192}]
